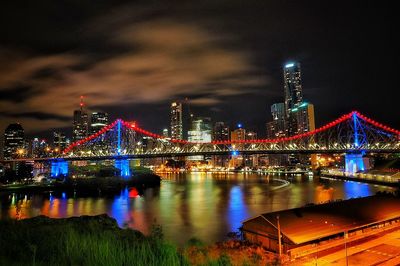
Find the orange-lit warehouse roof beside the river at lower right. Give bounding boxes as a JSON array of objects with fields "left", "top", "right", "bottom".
[{"left": 244, "top": 196, "right": 400, "bottom": 244}]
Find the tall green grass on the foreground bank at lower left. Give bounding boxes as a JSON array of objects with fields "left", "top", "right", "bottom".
[{"left": 0, "top": 215, "right": 188, "bottom": 266}]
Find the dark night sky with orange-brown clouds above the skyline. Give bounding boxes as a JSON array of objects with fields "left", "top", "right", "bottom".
[{"left": 0, "top": 0, "right": 400, "bottom": 141}]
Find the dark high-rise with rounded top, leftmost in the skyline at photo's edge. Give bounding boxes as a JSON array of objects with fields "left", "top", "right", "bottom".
[{"left": 3, "top": 123, "right": 27, "bottom": 160}]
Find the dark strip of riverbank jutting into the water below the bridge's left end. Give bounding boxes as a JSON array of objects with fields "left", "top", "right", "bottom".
[{"left": 0, "top": 173, "right": 161, "bottom": 195}]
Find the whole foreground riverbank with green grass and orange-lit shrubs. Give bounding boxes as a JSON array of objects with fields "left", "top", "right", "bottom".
[{"left": 0, "top": 215, "right": 276, "bottom": 265}]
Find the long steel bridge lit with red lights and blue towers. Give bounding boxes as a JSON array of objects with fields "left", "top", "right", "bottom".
[{"left": 3, "top": 111, "right": 400, "bottom": 175}]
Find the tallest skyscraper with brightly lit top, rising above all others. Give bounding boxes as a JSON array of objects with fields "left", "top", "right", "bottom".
[{"left": 283, "top": 62, "right": 303, "bottom": 117}]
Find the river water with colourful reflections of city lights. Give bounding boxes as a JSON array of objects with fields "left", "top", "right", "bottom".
[{"left": 0, "top": 173, "right": 392, "bottom": 245}]
